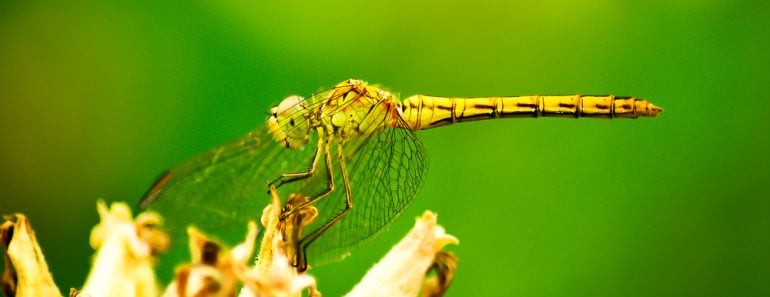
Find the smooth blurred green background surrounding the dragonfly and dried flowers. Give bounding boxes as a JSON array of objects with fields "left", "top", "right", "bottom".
[{"left": 0, "top": 0, "right": 770, "bottom": 296}]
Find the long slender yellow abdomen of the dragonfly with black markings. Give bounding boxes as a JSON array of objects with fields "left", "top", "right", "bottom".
[{"left": 401, "top": 95, "right": 663, "bottom": 130}]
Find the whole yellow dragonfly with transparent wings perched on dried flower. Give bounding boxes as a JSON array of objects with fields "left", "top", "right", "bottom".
[{"left": 140, "top": 79, "right": 663, "bottom": 271}]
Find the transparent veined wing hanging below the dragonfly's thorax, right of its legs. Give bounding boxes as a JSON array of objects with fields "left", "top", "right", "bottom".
[{"left": 306, "top": 114, "right": 428, "bottom": 266}]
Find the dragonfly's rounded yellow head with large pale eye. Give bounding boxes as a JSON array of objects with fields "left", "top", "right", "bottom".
[{"left": 267, "top": 96, "right": 310, "bottom": 149}]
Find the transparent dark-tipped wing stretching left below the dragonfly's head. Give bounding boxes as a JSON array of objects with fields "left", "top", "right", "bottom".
[{"left": 140, "top": 88, "right": 348, "bottom": 265}]
